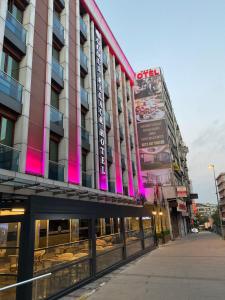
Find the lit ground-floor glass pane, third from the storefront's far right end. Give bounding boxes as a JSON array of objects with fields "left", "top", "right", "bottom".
[{"left": 96, "top": 218, "right": 124, "bottom": 272}]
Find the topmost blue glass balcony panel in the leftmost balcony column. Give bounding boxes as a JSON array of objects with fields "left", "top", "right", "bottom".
[{"left": 5, "top": 11, "right": 27, "bottom": 43}]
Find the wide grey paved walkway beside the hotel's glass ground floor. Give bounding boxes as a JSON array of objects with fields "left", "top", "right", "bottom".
[{"left": 63, "top": 232, "right": 225, "bottom": 300}]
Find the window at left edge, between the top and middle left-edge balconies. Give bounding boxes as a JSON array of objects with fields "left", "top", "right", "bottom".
[{"left": 1, "top": 51, "right": 19, "bottom": 80}]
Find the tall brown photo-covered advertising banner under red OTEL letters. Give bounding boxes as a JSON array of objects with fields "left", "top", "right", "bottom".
[{"left": 134, "top": 68, "right": 172, "bottom": 203}]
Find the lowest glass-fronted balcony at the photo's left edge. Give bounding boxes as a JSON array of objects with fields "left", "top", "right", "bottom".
[{"left": 0, "top": 144, "right": 20, "bottom": 172}]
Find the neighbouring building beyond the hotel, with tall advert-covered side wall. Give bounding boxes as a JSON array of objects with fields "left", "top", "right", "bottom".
[{"left": 134, "top": 68, "right": 191, "bottom": 237}]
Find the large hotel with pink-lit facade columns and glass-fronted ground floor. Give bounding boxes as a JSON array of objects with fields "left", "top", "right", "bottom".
[{"left": 0, "top": 0, "right": 154, "bottom": 300}]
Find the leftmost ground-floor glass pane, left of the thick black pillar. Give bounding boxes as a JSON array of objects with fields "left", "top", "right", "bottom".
[{"left": 0, "top": 222, "right": 21, "bottom": 300}]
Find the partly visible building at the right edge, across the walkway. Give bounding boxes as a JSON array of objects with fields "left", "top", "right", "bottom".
[{"left": 216, "top": 173, "right": 225, "bottom": 236}]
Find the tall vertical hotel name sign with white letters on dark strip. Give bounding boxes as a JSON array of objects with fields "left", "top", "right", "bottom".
[{"left": 95, "top": 29, "right": 107, "bottom": 190}]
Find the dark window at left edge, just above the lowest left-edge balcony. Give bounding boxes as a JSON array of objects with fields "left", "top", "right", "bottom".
[{"left": 0, "top": 117, "right": 14, "bottom": 147}]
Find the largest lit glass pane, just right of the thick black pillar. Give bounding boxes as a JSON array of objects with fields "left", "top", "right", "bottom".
[{"left": 32, "top": 219, "right": 91, "bottom": 300}]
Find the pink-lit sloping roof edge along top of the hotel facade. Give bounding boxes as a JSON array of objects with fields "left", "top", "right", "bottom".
[{"left": 81, "top": 0, "right": 135, "bottom": 84}]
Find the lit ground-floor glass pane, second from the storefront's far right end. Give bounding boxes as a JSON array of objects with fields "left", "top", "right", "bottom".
[{"left": 124, "top": 217, "right": 142, "bottom": 257}]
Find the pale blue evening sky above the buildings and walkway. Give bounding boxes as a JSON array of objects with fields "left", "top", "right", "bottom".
[{"left": 96, "top": 0, "right": 225, "bottom": 202}]
